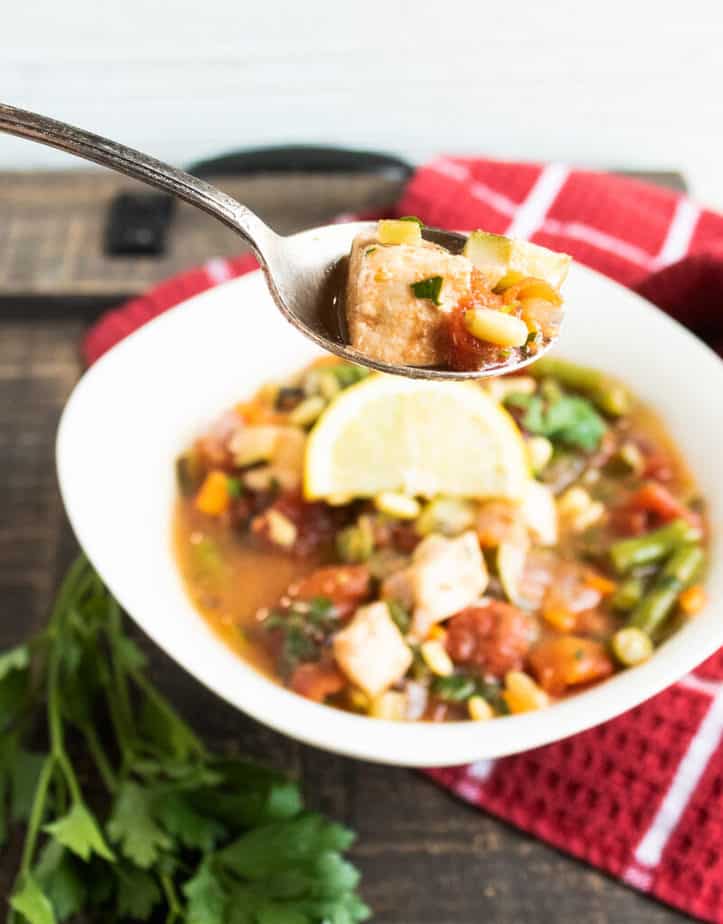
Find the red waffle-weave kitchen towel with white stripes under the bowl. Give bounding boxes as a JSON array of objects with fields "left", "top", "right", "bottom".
[{"left": 84, "top": 157, "right": 723, "bottom": 924}]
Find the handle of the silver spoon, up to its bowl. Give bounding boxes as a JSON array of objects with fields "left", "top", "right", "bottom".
[{"left": 0, "top": 103, "right": 277, "bottom": 254}]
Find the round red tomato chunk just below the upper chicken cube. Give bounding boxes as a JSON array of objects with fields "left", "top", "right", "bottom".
[{"left": 446, "top": 600, "right": 532, "bottom": 678}]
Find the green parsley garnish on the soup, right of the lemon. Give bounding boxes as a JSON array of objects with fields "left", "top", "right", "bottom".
[{"left": 505, "top": 393, "right": 607, "bottom": 452}]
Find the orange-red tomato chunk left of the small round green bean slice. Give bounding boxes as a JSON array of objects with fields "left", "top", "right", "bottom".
[{"left": 530, "top": 635, "right": 613, "bottom": 696}]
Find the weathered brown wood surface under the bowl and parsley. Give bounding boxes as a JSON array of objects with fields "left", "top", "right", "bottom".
[{"left": 0, "top": 172, "right": 686, "bottom": 924}]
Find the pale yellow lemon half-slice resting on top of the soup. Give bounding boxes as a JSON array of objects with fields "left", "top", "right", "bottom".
[{"left": 304, "top": 375, "right": 530, "bottom": 501}]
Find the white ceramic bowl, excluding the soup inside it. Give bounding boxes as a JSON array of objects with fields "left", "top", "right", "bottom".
[{"left": 57, "top": 235, "right": 723, "bottom": 766}]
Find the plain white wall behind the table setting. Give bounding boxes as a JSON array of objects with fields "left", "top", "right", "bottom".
[{"left": 0, "top": 0, "right": 723, "bottom": 207}]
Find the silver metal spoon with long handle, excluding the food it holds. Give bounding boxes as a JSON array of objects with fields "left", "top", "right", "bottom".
[{"left": 0, "top": 103, "right": 552, "bottom": 379}]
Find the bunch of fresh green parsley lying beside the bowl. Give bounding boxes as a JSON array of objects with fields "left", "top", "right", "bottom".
[{"left": 0, "top": 558, "right": 369, "bottom": 924}]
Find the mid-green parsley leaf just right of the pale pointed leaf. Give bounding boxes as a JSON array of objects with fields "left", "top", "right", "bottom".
[{"left": 108, "top": 781, "right": 171, "bottom": 869}]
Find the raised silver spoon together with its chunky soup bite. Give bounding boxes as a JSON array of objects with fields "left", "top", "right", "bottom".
[{"left": 0, "top": 104, "right": 570, "bottom": 379}]
